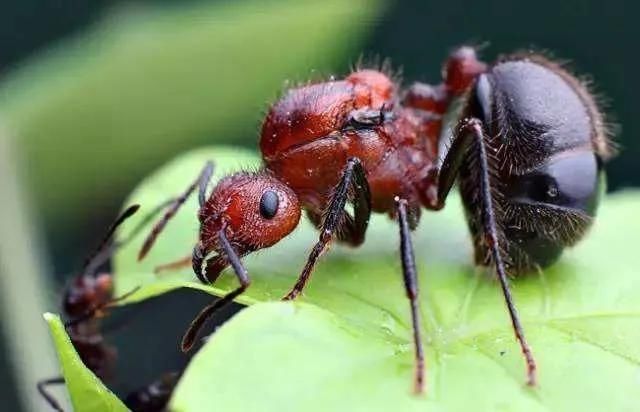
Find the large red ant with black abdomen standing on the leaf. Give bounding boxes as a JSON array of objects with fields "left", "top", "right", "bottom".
[{"left": 139, "top": 47, "right": 614, "bottom": 393}]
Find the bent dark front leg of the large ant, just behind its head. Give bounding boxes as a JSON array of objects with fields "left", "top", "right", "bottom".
[{"left": 283, "top": 158, "right": 371, "bottom": 300}]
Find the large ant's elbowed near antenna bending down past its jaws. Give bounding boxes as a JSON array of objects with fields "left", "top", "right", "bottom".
[{"left": 181, "top": 226, "right": 251, "bottom": 352}]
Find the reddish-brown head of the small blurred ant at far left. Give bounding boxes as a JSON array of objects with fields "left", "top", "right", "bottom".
[{"left": 62, "top": 273, "right": 113, "bottom": 318}]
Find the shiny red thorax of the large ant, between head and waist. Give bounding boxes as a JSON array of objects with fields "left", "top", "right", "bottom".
[{"left": 260, "top": 70, "right": 440, "bottom": 214}]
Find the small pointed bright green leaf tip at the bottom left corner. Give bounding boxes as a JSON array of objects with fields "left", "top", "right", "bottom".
[{"left": 44, "top": 313, "right": 129, "bottom": 412}]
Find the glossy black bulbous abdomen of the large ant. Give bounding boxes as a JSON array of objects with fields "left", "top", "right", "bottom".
[{"left": 468, "top": 54, "right": 610, "bottom": 270}]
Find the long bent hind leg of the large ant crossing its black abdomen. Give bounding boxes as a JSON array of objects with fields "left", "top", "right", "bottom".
[{"left": 438, "top": 118, "right": 536, "bottom": 386}]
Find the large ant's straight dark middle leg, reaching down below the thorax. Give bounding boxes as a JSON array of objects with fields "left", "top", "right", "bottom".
[{"left": 395, "top": 197, "right": 424, "bottom": 393}]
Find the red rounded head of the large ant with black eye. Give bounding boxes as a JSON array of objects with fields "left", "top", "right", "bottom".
[{"left": 199, "top": 172, "right": 301, "bottom": 255}]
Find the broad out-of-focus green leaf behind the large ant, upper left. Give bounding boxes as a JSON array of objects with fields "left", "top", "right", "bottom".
[{"left": 0, "top": 0, "right": 382, "bottom": 222}]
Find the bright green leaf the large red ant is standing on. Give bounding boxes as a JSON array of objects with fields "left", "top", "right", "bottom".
[{"left": 116, "top": 148, "right": 640, "bottom": 411}]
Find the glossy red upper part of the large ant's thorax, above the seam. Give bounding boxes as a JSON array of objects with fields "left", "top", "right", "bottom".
[{"left": 260, "top": 70, "right": 395, "bottom": 159}]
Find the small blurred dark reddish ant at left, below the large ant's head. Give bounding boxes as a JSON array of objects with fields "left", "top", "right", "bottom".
[{"left": 37, "top": 203, "right": 174, "bottom": 411}]
